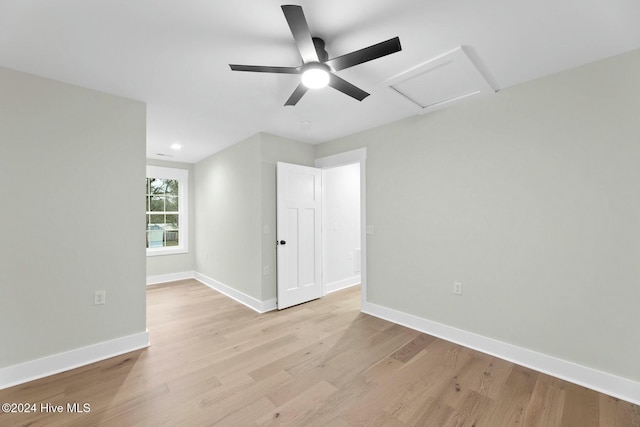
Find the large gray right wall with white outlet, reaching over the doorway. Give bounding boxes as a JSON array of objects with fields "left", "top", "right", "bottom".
[{"left": 316, "top": 51, "right": 640, "bottom": 381}]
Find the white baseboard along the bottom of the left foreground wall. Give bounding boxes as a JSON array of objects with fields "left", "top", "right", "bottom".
[{"left": 0, "top": 331, "right": 149, "bottom": 390}]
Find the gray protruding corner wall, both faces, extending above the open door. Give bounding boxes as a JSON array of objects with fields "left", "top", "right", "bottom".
[{"left": 194, "top": 133, "right": 314, "bottom": 301}]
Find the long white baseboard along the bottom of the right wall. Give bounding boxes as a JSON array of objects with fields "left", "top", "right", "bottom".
[{"left": 361, "top": 302, "right": 640, "bottom": 405}]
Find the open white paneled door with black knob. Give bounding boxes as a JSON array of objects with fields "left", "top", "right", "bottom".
[{"left": 277, "top": 162, "right": 322, "bottom": 310}]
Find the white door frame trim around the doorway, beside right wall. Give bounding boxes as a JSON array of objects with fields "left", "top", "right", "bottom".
[{"left": 315, "top": 148, "right": 367, "bottom": 307}]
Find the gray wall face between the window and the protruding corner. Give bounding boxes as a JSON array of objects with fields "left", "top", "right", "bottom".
[{"left": 194, "top": 134, "right": 262, "bottom": 300}]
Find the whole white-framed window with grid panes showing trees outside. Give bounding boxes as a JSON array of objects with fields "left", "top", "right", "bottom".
[{"left": 145, "top": 166, "right": 189, "bottom": 256}]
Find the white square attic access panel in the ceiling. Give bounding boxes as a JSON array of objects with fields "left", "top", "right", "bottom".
[{"left": 387, "top": 47, "right": 495, "bottom": 113}]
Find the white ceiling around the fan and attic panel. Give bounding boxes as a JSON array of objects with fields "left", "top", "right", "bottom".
[{"left": 0, "top": 0, "right": 640, "bottom": 163}]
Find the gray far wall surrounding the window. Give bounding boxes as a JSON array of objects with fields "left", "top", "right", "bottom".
[{"left": 147, "top": 159, "right": 196, "bottom": 276}]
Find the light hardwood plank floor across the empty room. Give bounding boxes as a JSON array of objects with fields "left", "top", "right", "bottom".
[{"left": 0, "top": 280, "right": 640, "bottom": 427}]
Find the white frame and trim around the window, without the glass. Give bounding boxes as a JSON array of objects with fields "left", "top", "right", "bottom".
[{"left": 145, "top": 165, "right": 189, "bottom": 256}]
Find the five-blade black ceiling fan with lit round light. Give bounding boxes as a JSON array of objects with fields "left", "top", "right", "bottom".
[{"left": 229, "top": 5, "right": 402, "bottom": 105}]
